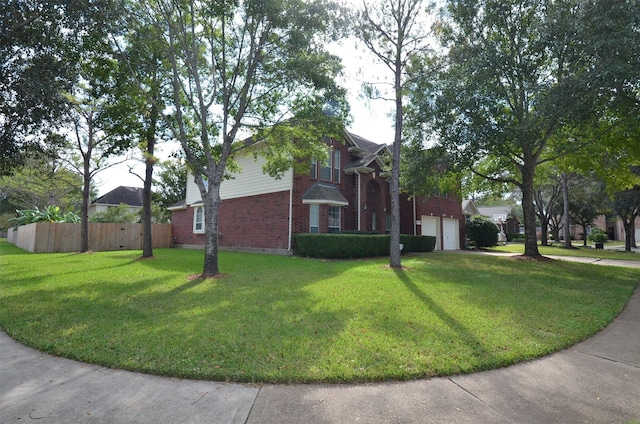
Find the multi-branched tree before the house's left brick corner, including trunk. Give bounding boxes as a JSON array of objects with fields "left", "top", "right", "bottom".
[{"left": 143, "top": 0, "right": 346, "bottom": 277}]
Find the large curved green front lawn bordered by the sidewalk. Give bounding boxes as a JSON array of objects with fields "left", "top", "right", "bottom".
[{"left": 0, "top": 240, "right": 638, "bottom": 382}]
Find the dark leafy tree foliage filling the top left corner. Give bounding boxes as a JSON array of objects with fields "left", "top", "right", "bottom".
[{"left": 0, "top": 0, "right": 114, "bottom": 174}]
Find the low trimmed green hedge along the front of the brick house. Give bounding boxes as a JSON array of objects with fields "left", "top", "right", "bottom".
[{"left": 295, "top": 234, "right": 436, "bottom": 258}]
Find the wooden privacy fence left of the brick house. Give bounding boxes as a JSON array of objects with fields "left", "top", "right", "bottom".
[{"left": 7, "top": 222, "right": 171, "bottom": 253}]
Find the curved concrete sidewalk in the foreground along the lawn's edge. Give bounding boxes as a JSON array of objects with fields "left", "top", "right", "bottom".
[{"left": 0, "top": 272, "right": 640, "bottom": 424}]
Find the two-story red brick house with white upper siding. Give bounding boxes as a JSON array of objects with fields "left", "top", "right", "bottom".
[{"left": 169, "top": 131, "right": 464, "bottom": 253}]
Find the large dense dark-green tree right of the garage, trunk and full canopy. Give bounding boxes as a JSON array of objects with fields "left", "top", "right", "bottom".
[{"left": 421, "top": 0, "right": 638, "bottom": 256}]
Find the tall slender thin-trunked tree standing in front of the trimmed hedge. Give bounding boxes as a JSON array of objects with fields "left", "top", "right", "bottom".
[{"left": 356, "top": 0, "right": 431, "bottom": 268}]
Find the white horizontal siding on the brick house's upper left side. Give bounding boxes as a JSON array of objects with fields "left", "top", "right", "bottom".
[{"left": 187, "top": 153, "right": 293, "bottom": 205}]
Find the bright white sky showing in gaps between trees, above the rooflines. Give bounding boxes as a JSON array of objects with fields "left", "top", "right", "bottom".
[{"left": 94, "top": 39, "right": 394, "bottom": 196}]
